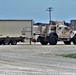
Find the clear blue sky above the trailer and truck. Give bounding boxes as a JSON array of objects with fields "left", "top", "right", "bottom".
[{"left": 0, "top": 0, "right": 76, "bottom": 23}]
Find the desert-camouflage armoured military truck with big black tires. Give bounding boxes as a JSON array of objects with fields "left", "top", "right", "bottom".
[{"left": 34, "top": 24, "right": 76, "bottom": 45}]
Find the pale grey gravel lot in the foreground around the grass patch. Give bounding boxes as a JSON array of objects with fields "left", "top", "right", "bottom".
[{"left": 0, "top": 44, "right": 76, "bottom": 75}]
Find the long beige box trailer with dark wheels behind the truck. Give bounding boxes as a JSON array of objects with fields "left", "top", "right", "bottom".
[{"left": 0, "top": 20, "right": 33, "bottom": 45}]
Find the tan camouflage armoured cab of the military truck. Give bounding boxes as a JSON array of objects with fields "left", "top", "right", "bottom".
[{"left": 56, "top": 25, "right": 75, "bottom": 41}]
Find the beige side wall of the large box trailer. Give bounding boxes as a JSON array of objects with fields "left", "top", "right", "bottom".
[{"left": 0, "top": 20, "right": 32, "bottom": 38}]
